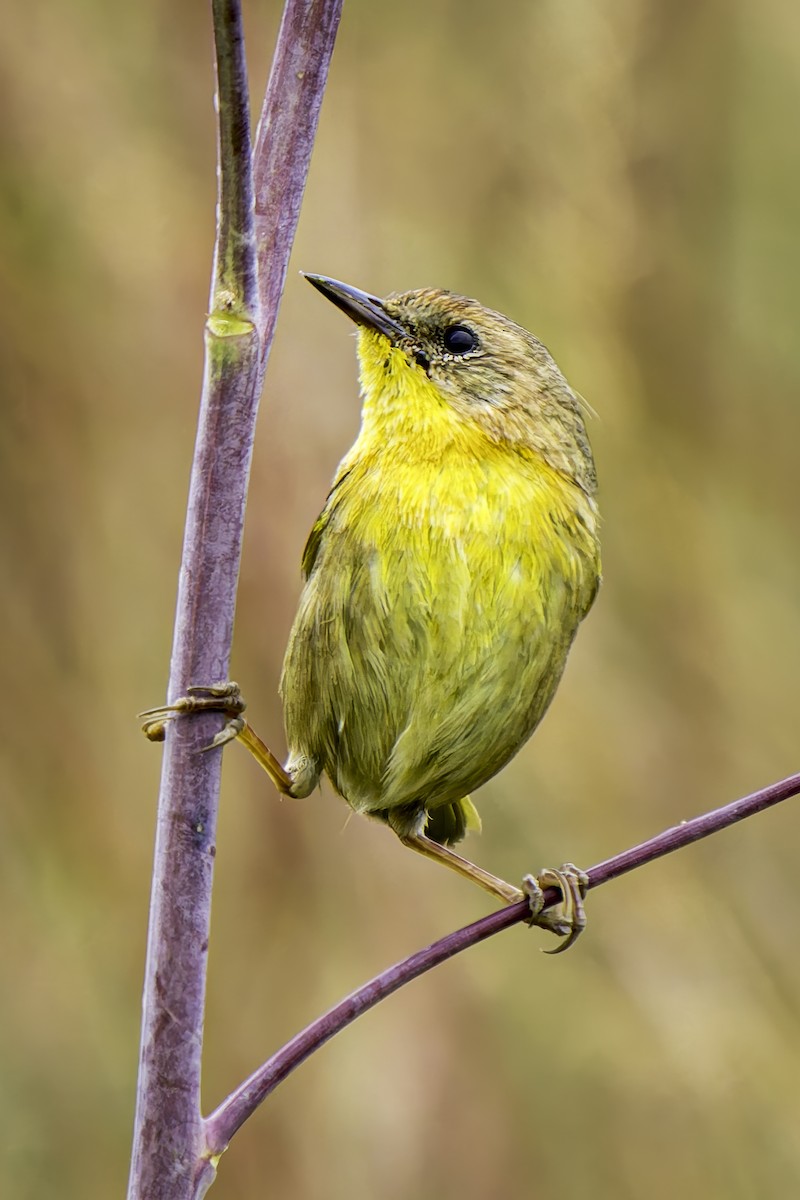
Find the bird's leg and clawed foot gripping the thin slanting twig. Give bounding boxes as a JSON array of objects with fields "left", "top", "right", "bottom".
[{"left": 401, "top": 834, "right": 589, "bottom": 954}]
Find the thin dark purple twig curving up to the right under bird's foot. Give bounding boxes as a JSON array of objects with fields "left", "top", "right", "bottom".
[{"left": 205, "top": 774, "right": 800, "bottom": 1153}]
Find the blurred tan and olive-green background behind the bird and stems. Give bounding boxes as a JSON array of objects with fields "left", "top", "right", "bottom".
[{"left": 0, "top": 0, "right": 800, "bottom": 1200}]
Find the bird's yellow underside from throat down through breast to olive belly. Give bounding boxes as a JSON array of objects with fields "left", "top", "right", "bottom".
[{"left": 283, "top": 338, "right": 599, "bottom": 811}]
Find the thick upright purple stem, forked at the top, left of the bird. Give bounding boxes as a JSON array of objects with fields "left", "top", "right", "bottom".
[{"left": 128, "top": 0, "right": 341, "bottom": 1200}]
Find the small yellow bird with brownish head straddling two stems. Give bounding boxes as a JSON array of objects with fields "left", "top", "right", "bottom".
[{"left": 145, "top": 275, "right": 600, "bottom": 948}]
